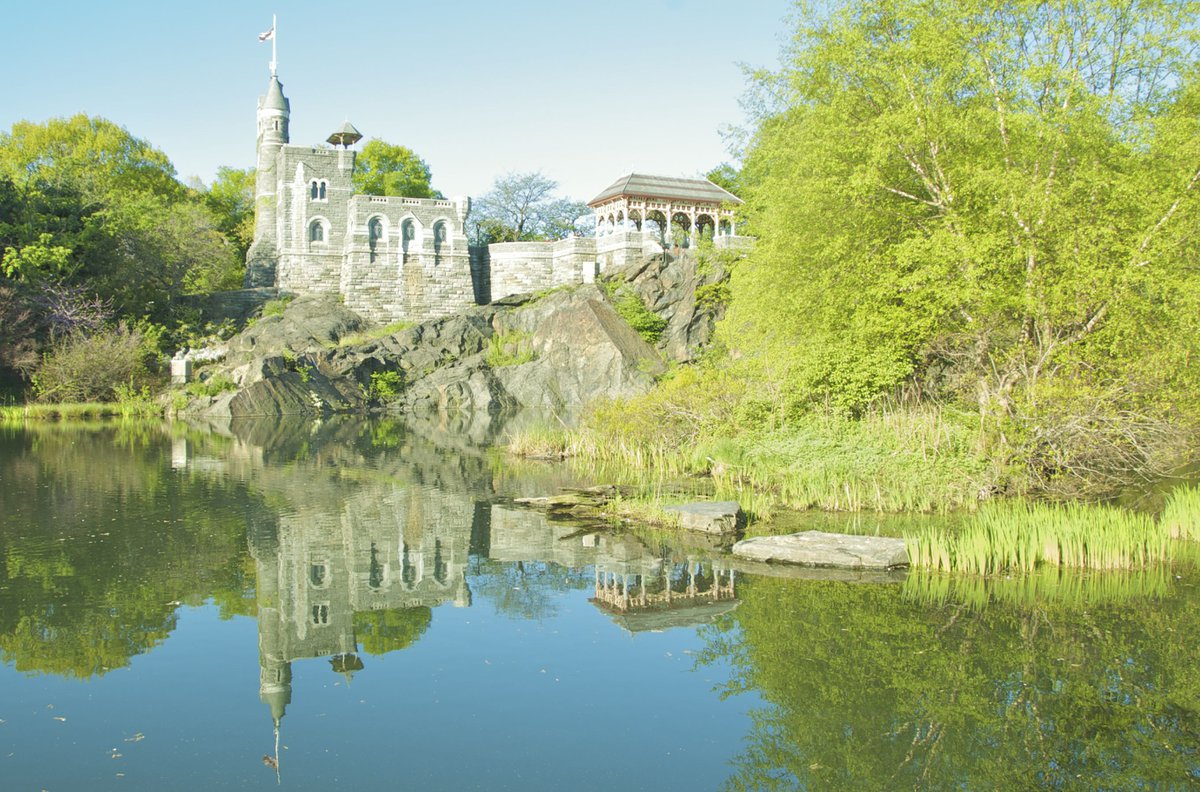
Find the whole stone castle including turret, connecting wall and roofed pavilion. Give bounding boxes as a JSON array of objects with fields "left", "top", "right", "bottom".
[{"left": 238, "top": 68, "right": 743, "bottom": 322}]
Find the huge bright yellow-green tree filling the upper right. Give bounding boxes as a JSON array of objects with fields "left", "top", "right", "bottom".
[{"left": 724, "top": 0, "right": 1200, "bottom": 470}]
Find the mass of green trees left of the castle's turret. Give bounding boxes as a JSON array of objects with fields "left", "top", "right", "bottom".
[{"left": 0, "top": 114, "right": 241, "bottom": 384}]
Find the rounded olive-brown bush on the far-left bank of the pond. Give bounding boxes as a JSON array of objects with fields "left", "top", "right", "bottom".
[{"left": 34, "top": 323, "right": 157, "bottom": 402}]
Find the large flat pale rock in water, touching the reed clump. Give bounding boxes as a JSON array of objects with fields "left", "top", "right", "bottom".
[{"left": 733, "top": 530, "right": 908, "bottom": 569}]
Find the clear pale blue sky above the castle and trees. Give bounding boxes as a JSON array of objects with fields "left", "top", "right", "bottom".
[{"left": 0, "top": 0, "right": 791, "bottom": 200}]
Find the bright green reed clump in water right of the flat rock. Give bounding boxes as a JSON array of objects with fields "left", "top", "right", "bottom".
[{"left": 905, "top": 500, "right": 1170, "bottom": 575}]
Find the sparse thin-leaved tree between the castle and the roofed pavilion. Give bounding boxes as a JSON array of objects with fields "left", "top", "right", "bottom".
[{"left": 469, "top": 172, "right": 588, "bottom": 245}]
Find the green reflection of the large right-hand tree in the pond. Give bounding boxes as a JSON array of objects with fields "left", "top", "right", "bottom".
[{"left": 701, "top": 566, "right": 1200, "bottom": 790}]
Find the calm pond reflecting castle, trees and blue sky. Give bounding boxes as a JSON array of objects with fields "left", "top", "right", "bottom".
[{"left": 0, "top": 420, "right": 1200, "bottom": 791}]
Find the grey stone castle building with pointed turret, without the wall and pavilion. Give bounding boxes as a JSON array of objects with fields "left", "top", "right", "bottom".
[{"left": 238, "top": 74, "right": 475, "bottom": 322}]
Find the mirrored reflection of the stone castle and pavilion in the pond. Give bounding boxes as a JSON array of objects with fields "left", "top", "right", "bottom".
[{"left": 222, "top": 417, "right": 737, "bottom": 726}]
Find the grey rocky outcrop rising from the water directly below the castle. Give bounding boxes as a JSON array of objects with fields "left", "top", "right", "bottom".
[{"left": 186, "top": 286, "right": 665, "bottom": 422}]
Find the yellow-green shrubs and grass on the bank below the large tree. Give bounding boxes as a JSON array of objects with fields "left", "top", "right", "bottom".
[{"left": 549, "top": 367, "right": 996, "bottom": 516}]
